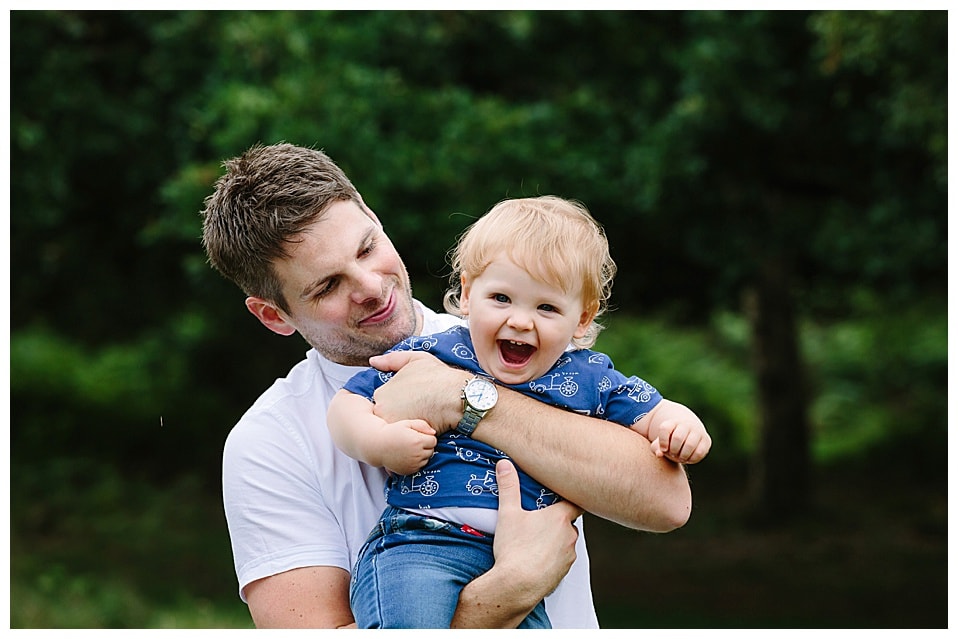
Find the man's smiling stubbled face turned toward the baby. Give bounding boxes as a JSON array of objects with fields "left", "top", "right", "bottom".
[{"left": 274, "top": 200, "right": 420, "bottom": 366}]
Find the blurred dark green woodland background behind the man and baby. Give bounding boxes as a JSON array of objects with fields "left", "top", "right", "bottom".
[{"left": 9, "top": 11, "right": 948, "bottom": 628}]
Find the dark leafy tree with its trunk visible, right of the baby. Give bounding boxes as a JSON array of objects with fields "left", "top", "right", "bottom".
[{"left": 624, "top": 12, "right": 947, "bottom": 521}]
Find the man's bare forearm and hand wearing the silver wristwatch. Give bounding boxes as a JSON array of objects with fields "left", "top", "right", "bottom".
[{"left": 370, "top": 351, "right": 692, "bottom": 532}]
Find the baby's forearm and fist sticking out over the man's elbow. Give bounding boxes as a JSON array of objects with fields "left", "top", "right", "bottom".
[{"left": 632, "top": 399, "right": 712, "bottom": 464}]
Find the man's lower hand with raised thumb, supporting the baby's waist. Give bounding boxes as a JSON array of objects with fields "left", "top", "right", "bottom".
[{"left": 452, "top": 460, "right": 582, "bottom": 628}]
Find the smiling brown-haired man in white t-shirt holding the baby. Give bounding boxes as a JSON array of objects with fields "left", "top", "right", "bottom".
[{"left": 203, "top": 144, "right": 691, "bottom": 628}]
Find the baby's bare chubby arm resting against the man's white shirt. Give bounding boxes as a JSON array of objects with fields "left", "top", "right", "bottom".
[{"left": 326, "top": 390, "right": 436, "bottom": 475}]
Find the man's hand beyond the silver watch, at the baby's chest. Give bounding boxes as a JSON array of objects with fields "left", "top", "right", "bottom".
[{"left": 369, "top": 351, "right": 472, "bottom": 435}]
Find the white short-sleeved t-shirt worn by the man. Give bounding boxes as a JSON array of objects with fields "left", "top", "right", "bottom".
[{"left": 223, "top": 307, "right": 598, "bottom": 628}]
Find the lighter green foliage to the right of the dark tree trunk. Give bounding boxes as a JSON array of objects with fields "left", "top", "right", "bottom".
[{"left": 804, "top": 296, "right": 948, "bottom": 469}]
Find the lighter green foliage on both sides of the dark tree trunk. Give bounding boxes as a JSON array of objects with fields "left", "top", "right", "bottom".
[{"left": 597, "top": 301, "right": 948, "bottom": 468}]
